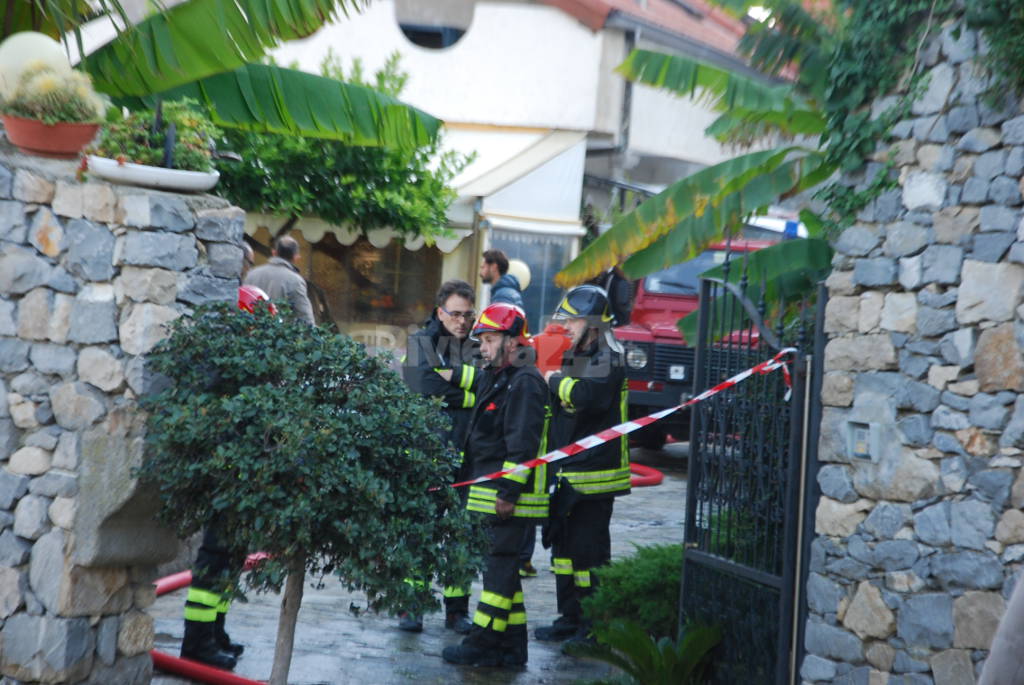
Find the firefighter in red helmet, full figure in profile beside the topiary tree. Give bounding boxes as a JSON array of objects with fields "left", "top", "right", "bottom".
[{"left": 442, "top": 303, "right": 549, "bottom": 667}]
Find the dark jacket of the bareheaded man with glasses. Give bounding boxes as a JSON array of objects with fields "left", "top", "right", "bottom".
[{"left": 401, "top": 316, "right": 480, "bottom": 447}]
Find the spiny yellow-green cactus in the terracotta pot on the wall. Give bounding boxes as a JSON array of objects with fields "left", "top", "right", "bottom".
[{"left": 0, "top": 63, "right": 106, "bottom": 124}]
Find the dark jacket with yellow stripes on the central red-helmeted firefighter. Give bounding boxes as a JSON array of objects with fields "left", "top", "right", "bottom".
[{"left": 452, "top": 365, "right": 550, "bottom": 520}]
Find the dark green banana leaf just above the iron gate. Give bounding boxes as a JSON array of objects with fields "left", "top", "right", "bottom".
[{"left": 678, "top": 238, "right": 833, "bottom": 341}]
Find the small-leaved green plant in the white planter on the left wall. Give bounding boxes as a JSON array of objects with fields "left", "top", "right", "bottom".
[{"left": 89, "top": 99, "right": 220, "bottom": 171}]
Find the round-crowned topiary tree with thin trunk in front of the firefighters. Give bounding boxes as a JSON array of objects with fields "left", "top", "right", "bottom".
[{"left": 139, "top": 303, "right": 482, "bottom": 684}]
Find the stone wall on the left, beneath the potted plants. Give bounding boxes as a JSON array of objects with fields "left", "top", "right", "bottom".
[{"left": 0, "top": 143, "right": 244, "bottom": 685}]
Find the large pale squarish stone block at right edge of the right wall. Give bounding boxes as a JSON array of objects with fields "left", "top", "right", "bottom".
[{"left": 956, "top": 259, "right": 1024, "bottom": 324}]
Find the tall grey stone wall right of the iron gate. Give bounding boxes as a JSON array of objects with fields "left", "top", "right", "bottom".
[{"left": 806, "top": 14, "right": 1024, "bottom": 685}]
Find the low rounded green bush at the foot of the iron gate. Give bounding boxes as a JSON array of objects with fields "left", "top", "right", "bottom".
[{"left": 583, "top": 545, "right": 683, "bottom": 637}]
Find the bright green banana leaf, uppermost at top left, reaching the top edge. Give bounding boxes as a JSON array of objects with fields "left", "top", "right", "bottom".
[{"left": 82, "top": 0, "right": 366, "bottom": 96}]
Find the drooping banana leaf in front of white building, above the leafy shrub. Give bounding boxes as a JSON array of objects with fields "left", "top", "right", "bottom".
[{"left": 119, "top": 65, "right": 440, "bottom": 147}]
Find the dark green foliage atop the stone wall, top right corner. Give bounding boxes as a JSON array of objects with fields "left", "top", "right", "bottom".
[{"left": 967, "top": 0, "right": 1024, "bottom": 96}]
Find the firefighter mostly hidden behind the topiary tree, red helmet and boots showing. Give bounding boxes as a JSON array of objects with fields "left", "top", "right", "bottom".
[{"left": 181, "top": 286, "right": 278, "bottom": 670}]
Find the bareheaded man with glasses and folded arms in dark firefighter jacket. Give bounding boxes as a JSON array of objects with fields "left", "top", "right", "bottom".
[{"left": 398, "top": 281, "right": 479, "bottom": 634}]
